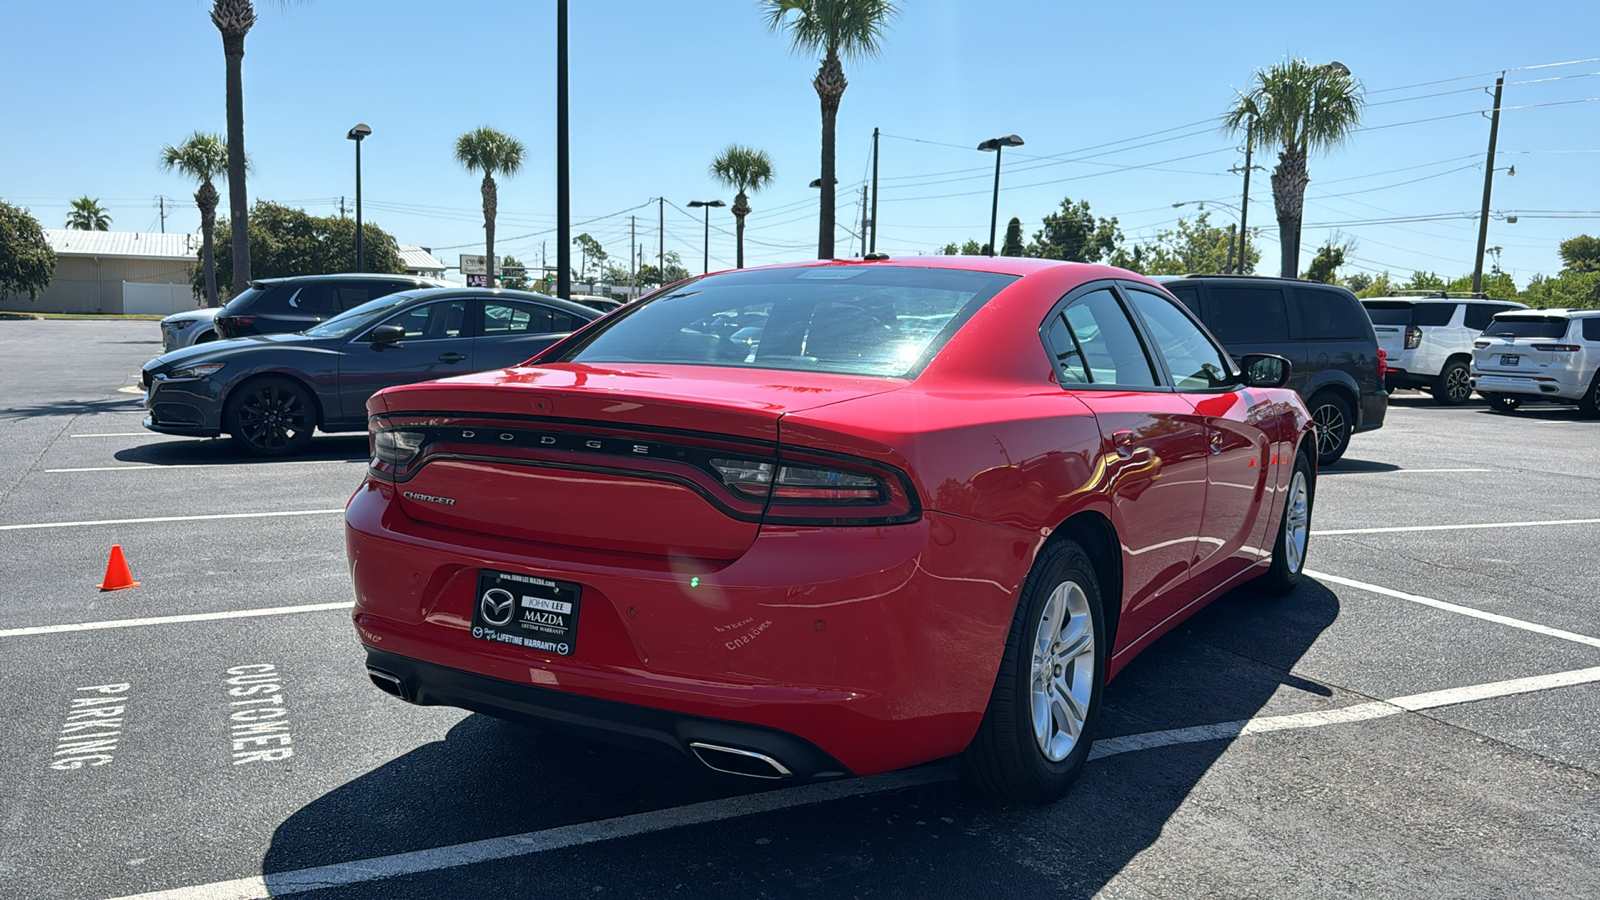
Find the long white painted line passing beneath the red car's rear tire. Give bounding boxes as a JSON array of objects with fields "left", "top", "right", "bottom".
[{"left": 109, "top": 666, "right": 1600, "bottom": 900}]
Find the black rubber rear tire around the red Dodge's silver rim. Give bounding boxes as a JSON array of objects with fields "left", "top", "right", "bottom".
[{"left": 957, "top": 540, "right": 1110, "bottom": 802}]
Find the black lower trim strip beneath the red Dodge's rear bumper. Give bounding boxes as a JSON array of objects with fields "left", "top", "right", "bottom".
[{"left": 366, "top": 647, "right": 850, "bottom": 780}]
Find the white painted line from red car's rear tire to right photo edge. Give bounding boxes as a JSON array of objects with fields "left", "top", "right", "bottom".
[{"left": 1090, "top": 666, "right": 1600, "bottom": 759}]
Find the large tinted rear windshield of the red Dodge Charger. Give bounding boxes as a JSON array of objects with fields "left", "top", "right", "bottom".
[{"left": 557, "top": 266, "right": 1016, "bottom": 378}]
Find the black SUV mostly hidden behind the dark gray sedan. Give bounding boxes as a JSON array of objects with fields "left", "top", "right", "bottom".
[{"left": 216, "top": 274, "right": 451, "bottom": 338}]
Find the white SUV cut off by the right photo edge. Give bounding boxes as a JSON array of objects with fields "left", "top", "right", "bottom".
[{"left": 1472, "top": 309, "right": 1600, "bottom": 416}]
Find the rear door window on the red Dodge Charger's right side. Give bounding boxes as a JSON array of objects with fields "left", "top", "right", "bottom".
[{"left": 1046, "top": 290, "right": 1155, "bottom": 388}]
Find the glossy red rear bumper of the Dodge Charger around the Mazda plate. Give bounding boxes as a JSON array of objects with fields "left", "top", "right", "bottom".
[{"left": 346, "top": 480, "right": 1040, "bottom": 775}]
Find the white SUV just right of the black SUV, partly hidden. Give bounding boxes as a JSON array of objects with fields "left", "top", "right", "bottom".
[{"left": 1362, "top": 291, "right": 1526, "bottom": 407}]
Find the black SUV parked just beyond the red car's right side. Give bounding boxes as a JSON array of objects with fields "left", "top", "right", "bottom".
[{"left": 1157, "top": 275, "right": 1389, "bottom": 466}]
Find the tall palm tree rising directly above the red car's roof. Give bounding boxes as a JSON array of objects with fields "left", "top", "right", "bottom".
[{"left": 760, "top": 0, "right": 899, "bottom": 259}]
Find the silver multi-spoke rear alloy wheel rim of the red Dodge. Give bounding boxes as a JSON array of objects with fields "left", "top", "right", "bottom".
[{"left": 1029, "top": 581, "right": 1094, "bottom": 762}]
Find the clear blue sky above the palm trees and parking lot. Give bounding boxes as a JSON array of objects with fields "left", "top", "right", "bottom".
[{"left": 0, "top": 0, "right": 1600, "bottom": 283}]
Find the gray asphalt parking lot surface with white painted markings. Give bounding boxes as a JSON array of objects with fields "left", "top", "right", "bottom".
[{"left": 0, "top": 322, "right": 1600, "bottom": 900}]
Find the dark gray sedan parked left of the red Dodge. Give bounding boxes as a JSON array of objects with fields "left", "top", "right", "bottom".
[{"left": 144, "top": 288, "right": 600, "bottom": 456}]
